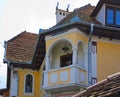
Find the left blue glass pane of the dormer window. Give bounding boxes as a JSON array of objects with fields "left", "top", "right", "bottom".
[{"left": 107, "top": 9, "right": 114, "bottom": 24}]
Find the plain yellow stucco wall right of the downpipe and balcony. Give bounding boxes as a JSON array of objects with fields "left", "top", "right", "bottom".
[{"left": 97, "top": 42, "right": 120, "bottom": 81}]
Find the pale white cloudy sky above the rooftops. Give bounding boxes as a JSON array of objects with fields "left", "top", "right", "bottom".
[{"left": 0, "top": 0, "right": 98, "bottom": 88}]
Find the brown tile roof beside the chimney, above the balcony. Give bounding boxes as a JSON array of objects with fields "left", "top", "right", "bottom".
[{"left": 56, "top": 4, "right": 100, "bottom": 26}]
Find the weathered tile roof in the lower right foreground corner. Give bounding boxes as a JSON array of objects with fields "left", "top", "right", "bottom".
[{"left": 73, "top": 72, "right": 120, "bottom": 97}]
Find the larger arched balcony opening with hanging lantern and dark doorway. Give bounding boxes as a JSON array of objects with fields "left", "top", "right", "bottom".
[{"left": 50, "top": 40, "right": 72, "bottom": 69}]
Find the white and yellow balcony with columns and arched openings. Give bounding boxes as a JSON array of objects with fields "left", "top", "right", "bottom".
[{"left": 43, "top": 40, "right": 88, "bottom": 91}]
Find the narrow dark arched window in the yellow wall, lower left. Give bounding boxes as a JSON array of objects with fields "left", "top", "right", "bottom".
[{"left": 25, "top": 74, "right": 33, "bottom": 93}]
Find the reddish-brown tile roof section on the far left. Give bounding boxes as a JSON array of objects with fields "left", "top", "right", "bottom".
[{"left": 6, "top": 31, "right": 38, "bottom": 63}]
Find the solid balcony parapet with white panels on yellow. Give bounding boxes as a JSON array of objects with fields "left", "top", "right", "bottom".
[{"left": 43, "top": 65, "right": 87, "bottom": 88}]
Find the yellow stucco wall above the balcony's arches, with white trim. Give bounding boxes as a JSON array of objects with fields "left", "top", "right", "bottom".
[{"left": 46, "top": 29, "right": 87, "bottom": 52}]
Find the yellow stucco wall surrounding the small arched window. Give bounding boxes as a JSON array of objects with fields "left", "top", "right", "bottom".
[{"left": 18, "top": 70, "right": 43, "bottom": 97}]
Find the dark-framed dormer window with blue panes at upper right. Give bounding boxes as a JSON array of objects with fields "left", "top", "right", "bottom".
[{"left": 106, "top": 6, "right": 120, "bottom": 27}]
